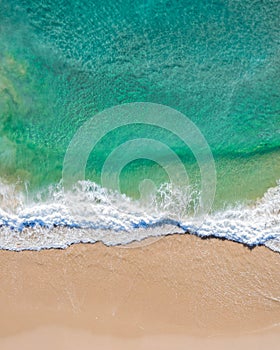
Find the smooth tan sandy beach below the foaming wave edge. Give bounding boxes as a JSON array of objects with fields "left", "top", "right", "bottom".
[{"left": 0, "top": 235, "right": 280, "bottom": 350}]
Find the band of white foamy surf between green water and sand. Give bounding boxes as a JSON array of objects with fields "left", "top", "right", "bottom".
[{"left": 0, "top": 181, "right": 280, "bottom": 252}]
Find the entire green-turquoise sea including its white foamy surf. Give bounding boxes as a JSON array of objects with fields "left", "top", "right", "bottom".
[{"left": 0, "top": 0, "right": 280, "bottom": 252}]
